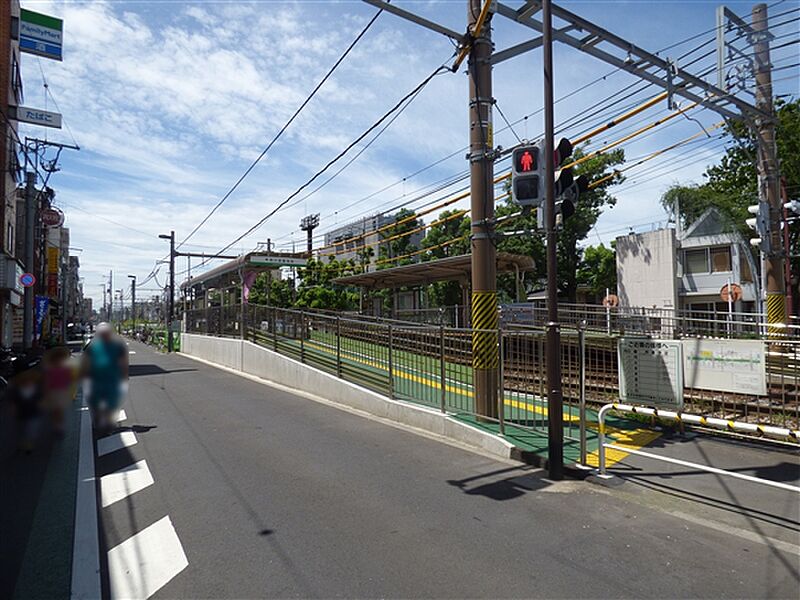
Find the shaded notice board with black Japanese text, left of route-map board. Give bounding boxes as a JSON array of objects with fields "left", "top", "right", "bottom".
[{"left": 617, "top": 338, "right": 683, "bottom": 410}]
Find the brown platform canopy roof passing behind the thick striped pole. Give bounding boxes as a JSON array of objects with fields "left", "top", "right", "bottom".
[{"left": 333, "top": 252, "right": 534, "bottom": 290}]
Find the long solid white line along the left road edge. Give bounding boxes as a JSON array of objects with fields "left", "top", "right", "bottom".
[{"left": 70, "top": 396, "right": 100, "bottom": 600}]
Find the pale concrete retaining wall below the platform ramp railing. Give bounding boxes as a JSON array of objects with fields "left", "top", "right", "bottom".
[{"left": 181, "top": 333, "right": 513, "bottom": 458}]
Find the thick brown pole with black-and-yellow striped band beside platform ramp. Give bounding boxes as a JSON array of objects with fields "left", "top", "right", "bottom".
[{"left": 467, "top": 0, "right": 499, "bottom": 418}]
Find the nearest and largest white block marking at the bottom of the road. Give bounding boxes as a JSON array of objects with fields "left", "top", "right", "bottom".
[{"left": 108, "top": 516, "right": 189, "bottom": 599}]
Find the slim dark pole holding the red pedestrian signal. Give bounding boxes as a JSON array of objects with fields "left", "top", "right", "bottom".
[{"left": 542, "top": 0, "right": 564, "bottom": 479}]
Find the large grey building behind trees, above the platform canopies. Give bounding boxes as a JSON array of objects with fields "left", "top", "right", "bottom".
[{"left": 319, "top": 214, "right": 425, "bottom": 264}]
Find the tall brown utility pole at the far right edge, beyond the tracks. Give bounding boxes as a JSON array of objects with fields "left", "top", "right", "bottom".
[{"left": 752, "top": 4, "right": 786, "bottom": 333}]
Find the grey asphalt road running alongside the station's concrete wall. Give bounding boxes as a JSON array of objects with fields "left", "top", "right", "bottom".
[{"left": 92, "top": 344, "right": 800, "bottom": 598}]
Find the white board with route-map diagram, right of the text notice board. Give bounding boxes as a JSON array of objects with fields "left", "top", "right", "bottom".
[{"left": 683, "top": 339, "right": 767, "bottom": 396}]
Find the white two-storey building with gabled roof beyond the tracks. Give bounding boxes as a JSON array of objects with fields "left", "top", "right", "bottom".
[{"left": 616, "top": 208, "right": 758, "bottom": 316}]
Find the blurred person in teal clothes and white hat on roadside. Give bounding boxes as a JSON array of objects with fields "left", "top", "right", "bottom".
[{"left": 83, "top": 323, "right": 128, "bottom": 430}]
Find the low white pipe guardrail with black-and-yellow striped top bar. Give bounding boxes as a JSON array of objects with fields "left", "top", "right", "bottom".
[{"left": 597, "top": 403, "right": 800, "bottom": 492}]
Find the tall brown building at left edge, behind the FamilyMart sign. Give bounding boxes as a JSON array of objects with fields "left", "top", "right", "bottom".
[{"left": 0, "top": 0, "right": 23, "bottom": 346}]
